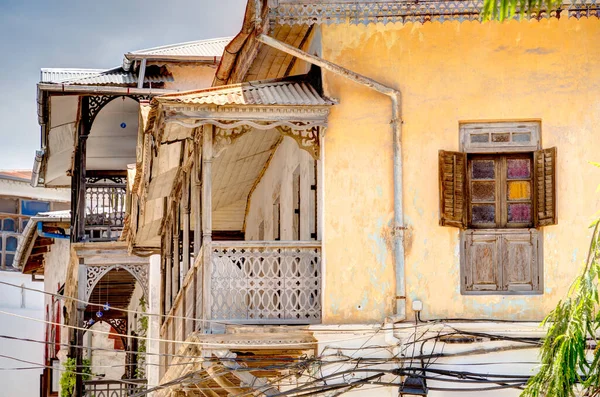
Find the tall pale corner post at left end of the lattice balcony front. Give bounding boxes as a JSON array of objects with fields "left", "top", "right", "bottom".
[{"left": 202, "top": 125, "right": 215, "bottom": 332}]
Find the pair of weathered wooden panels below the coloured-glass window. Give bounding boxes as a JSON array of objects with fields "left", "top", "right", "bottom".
[{"left": 461, "top": 229, "right": 542, "bottom": 293}]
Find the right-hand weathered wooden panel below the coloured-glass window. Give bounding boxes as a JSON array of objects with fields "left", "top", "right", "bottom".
[{"left": 502, "top": 230, "right": 540, "bottom": 291}]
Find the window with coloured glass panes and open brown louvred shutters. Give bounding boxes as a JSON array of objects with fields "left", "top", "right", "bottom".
[{"left": 439, "top": 148, "right": 557, "bottom": 229}]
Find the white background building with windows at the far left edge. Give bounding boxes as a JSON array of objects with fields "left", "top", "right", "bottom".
[{"left": 0, "top": 171, "right": 70, "bottom": 397}]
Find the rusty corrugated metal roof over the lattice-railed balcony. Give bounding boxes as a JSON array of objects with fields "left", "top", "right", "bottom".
[{"left": 157, "top": 79, "right": 335, "bottom": 106}]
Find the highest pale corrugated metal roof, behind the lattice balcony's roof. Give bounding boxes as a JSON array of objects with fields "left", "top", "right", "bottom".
[{"left": 125, "top": 37, "right": 233, "bottom": 58}]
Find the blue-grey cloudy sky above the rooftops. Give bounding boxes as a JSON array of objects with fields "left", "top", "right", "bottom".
[{"left": 0, "top": 0, "right": 246, "bottom": 170}]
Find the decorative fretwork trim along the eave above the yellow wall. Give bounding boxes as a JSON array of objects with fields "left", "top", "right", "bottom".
[{"left": 269, "top": 0, "right": 600, "bottom": 25}]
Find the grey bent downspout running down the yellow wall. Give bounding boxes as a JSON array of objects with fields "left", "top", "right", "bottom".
[{"left": 256, "top": 33, "right": 406, "bottom": 321}]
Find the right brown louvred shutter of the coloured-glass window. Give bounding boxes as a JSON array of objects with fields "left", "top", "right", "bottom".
[{"left": 533, "top": 147, "right": 557, "bottom": 227}]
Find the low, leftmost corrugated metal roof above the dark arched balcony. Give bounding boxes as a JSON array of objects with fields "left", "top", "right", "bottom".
[{"left": 41, "top": 67, "right": 173, "bottom": 85}]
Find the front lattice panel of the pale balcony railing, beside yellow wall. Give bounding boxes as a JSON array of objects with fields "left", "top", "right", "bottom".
[{"left": 210, "top": 246, "right": 321, "bottom": 324}]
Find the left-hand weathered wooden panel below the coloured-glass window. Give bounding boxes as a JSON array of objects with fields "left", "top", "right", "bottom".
[{"left": 464, "top": 231, "right": 501, "bottom": 291}]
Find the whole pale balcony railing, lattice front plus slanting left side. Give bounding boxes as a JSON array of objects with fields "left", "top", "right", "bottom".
[{"left": 161, "top": 241, "right": 322, "bottom": 344}]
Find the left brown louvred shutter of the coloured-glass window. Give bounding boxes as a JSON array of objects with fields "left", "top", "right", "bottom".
[{"left": 439, "top": 150, "right": 467, "bottom": 229}]
